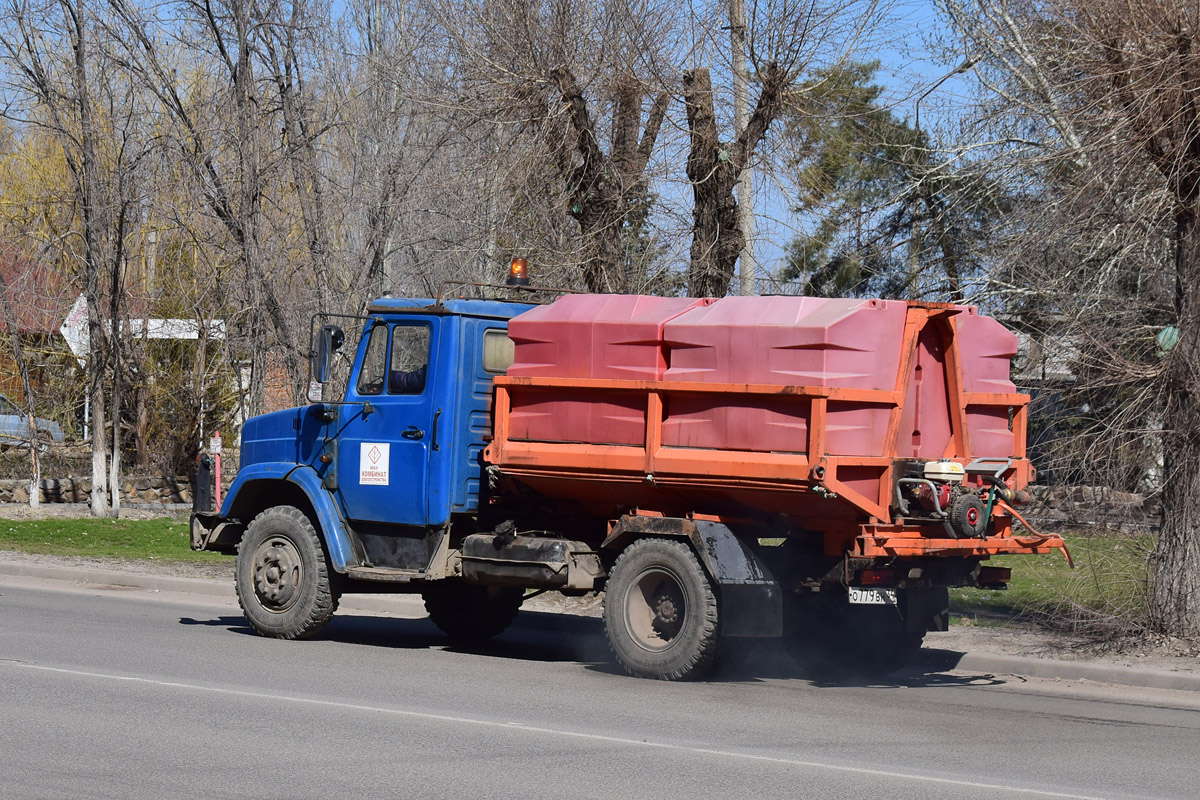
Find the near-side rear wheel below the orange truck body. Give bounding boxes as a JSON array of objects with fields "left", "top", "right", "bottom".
[{"left": 604, "top": 539, "right": 720, "bottom": 680}]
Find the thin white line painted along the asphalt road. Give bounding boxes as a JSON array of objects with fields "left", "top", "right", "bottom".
[{"left": 0, "top": 660, "right": 1104, "bottom": 800}]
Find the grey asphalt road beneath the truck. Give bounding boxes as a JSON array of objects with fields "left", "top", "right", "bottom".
[{"left": 0, "top": 578, "right": 1200, "bottom": 800}]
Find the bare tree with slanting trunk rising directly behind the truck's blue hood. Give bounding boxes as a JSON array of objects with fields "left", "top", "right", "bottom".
[{"left": 110, "top": 0, "right": 309, "bottom": 413}]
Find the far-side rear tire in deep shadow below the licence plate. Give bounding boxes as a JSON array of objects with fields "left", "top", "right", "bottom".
[{"left": 785, "top": 589, "right": 925, "bottom": 681}]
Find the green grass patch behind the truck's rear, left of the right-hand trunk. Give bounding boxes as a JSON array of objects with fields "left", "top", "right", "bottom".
[{"left": 950, "top": 534, "right": 1154, "bottom": 625}]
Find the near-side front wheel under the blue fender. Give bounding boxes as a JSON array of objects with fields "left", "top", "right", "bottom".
[{"left": 236, "top": 506, "right": 342, "bottom": 639}]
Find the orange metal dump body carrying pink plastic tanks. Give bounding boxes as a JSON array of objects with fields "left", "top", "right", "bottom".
[{"left": 485, "top": 295, "right": 1062, "bottom": 557}]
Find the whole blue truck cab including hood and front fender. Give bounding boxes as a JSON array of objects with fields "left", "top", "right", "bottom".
[{"left": 193, "top": 297, "right": 530, "bottom": 563}]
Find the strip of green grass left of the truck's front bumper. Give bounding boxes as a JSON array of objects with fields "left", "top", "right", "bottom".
[{"left": 0, "top": 517, "right": 228, "bottom": 561}]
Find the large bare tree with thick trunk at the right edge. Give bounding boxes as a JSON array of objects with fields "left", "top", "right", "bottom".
[{"left": 948, "top": 0, "right": 1200, "bottom": 638}]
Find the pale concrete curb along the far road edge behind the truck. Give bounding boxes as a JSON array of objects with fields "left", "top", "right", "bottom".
[{"left": 0, "top": 560, "right": 1200, "bottom": 692}]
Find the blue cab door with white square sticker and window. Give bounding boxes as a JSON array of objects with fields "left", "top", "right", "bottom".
[{"left": 337, "top": 317, "right": 438, "bottom": 525}]
